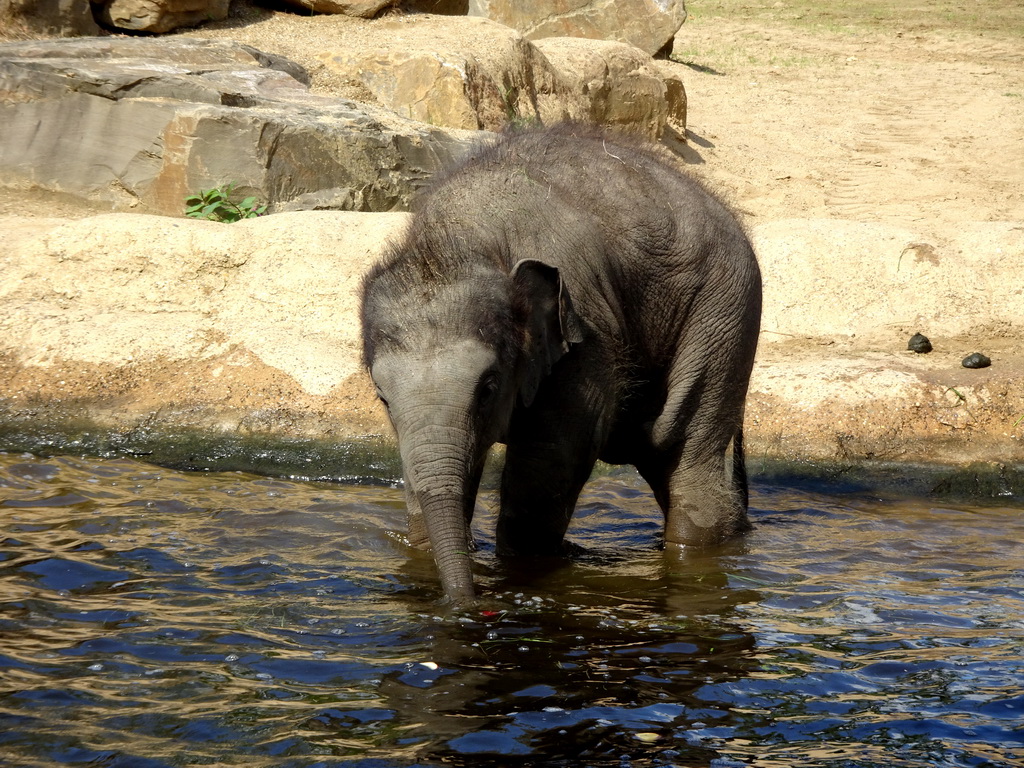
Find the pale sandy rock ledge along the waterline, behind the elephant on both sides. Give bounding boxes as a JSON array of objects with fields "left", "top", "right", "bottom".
[{"left": 0, "top": 211, "right": 1024, "bottom": 495}]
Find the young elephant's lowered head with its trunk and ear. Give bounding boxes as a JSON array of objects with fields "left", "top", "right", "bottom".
[{"left": 361, "top": 243, "right": 583, "bottom": 601}]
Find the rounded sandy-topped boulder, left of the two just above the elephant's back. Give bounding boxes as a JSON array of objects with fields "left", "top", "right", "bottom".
[{"left": 318, "top": 15, "right": 571, "bottom": 130}]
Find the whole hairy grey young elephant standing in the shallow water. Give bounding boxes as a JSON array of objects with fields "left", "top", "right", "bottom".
[{"left": 362, "top": 125, "right": 761, "bottom": 602}]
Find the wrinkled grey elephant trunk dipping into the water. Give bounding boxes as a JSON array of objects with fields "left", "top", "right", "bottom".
[{"left": 400, "top": 417, "right": 479, "bottom": 603}]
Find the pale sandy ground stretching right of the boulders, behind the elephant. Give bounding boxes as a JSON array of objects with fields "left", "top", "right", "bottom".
[{"left": 676, "top": 3, "right": 1024, "bottom": 232}]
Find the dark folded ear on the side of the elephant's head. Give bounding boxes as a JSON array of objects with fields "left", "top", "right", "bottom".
[{"left": 510, "top": 259, "right": 583, "bottom": 407}]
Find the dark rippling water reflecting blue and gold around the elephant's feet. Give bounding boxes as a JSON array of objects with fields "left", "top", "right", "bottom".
[{"left": 0, "top": 454, "right": 1024, "bottom": 768}]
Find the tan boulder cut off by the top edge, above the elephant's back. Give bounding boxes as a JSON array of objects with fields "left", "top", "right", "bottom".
[{"left": 468, "top": 0, "right": 686, "bottom": 54}]
